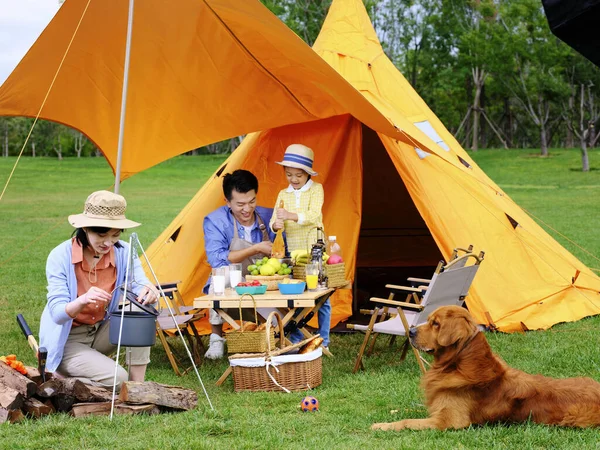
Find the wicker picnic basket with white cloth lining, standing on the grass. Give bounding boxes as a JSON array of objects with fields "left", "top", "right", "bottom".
[{"left": 229, "top": 311, "right": 323, "bottom": 392}]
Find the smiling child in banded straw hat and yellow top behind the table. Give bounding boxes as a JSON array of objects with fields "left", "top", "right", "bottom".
[{"left": 269, "top": 144, "right": 331, "bottom": 348}]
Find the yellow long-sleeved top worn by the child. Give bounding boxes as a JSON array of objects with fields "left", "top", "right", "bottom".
[{"left": 269, "top": 180, "right": 325, "bottom": 252}]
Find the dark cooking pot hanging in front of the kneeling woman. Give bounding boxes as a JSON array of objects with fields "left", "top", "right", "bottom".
[{"left": 108, "top": 291, "right": 158, "bottom": 347}]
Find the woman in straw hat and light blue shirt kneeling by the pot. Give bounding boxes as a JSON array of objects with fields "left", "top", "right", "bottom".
[{"left": 40, "top": 191, "right": 158, "bottom": 387}]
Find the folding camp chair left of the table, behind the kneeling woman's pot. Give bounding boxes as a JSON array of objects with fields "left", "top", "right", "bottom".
[{"left": 156, "top": 282, "right": 205, "bottom": 376}]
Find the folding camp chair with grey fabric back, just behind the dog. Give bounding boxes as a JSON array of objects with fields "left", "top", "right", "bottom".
[{"left": 348, "top": 250, "right": 484, "bottom": 373}]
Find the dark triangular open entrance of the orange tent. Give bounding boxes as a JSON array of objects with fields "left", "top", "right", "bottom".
[{"left": 353, "top": 125, "right": 443, "bottom": 312}]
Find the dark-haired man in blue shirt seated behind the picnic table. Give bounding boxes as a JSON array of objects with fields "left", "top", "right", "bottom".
[{"left": 203, "top": 170, "right": 274, "bottom": 359}]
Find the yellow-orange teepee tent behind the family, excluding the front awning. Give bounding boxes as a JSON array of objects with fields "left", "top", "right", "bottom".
[{"left": 144, "top": 0, "right": 600, "bottom": 331}]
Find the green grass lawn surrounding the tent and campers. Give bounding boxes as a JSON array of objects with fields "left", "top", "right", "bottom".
[{"left": 0, "top": 150, "right": 600, "bottom": 449}]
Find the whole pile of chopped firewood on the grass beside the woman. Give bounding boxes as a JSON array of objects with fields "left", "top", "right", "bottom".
[{"left": 0, "top": 361, "right": 198, "bottom": 423}]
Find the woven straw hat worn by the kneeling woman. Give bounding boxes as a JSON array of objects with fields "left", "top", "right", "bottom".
[{"left": 69, "top": 191, "right": 141, "bottom": 230}]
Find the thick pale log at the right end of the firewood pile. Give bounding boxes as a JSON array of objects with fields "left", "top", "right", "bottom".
[{"left": 119, "top": 381, "right": 198, "bottom": 411}]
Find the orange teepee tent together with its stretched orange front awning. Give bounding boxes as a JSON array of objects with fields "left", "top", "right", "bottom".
[{"left": 0, "top": 0, "right": 600, "bottom": 331}]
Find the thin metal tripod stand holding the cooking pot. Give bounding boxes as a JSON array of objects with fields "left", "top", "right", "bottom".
[{"left": 110, "top": 233, "right": 215, "bottom": 420}]
